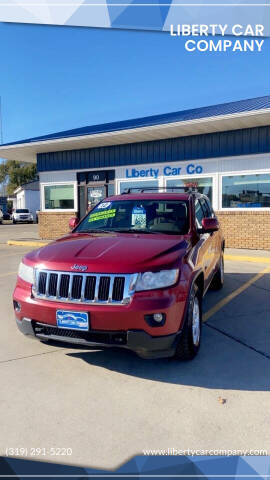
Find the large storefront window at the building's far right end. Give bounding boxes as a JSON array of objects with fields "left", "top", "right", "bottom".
[{"left": 222, "top": 173, "right": 270, "bottom": 208}]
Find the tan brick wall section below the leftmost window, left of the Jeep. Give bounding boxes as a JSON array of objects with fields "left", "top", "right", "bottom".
[{"left": 39, "top": 212, "right": 76, "bottom": 240}]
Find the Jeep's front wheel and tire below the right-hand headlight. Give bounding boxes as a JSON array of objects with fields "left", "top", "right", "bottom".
[{"left": 175, "top": 285, "right": 202, "bottom": 360}]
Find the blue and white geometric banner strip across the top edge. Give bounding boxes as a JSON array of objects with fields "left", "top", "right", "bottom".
[{"left": 0, "top": 0, "right": 270, "bottom": 36}]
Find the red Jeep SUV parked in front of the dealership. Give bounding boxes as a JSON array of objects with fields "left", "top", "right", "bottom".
[{"left": 13, "top": 191, "right": 224, "bottom": 359}]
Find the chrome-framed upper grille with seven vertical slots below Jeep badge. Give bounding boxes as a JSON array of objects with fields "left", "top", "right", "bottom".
[{"left": 33, "top": 269, "right": 137, "bottom": 305}]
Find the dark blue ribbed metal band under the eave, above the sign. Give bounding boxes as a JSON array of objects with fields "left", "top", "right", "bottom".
[{"left": 37, "top": 126, "right": 270, "bottom": 172}]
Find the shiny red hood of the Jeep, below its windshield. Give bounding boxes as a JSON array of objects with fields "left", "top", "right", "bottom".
[{"left": 25, "top": 233, "right": 190, "bottom": 273}]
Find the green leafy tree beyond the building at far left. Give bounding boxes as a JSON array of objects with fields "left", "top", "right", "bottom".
[{"left": 0, "top": 160, "right": 37, "bottom": 195}]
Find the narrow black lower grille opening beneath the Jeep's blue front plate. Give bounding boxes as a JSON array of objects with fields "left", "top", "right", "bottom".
[{"left": 33, "top": 322, "right": 127, "bottom": 345}]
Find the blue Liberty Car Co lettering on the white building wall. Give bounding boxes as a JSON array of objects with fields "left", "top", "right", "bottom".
[{"left": 126, "top": 163, "right": 203, "bottom": 178}]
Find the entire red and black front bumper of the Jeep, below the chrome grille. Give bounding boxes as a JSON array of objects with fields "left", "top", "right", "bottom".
[{"left": 13, "top": 277, "right": 187, "bottom": 358}]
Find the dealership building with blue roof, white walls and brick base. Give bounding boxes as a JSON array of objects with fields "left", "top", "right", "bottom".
[{"left": 0, "top": 96, "right": 270, "bottom": 250}]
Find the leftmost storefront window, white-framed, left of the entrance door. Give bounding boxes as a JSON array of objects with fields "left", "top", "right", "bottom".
[{"left": 44, "top": 185, "right": 74, "bottom": 210}]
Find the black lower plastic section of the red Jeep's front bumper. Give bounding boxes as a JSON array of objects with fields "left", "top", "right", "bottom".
[{"left": 16, "top": 318, "right": 181, "bottom": 359}]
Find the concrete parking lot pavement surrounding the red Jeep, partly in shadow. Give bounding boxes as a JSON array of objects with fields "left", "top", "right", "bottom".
[{"left": 0, "top": 230, "right": 270, "bottom": 468}]
